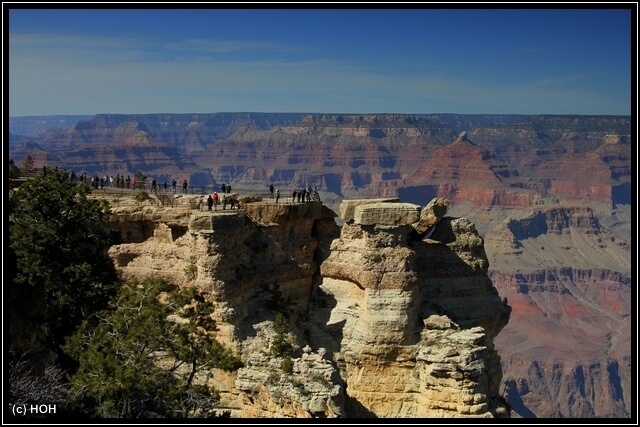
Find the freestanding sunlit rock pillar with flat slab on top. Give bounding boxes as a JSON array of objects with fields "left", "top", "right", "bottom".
[{"left": 311, "top": 203, "right": 510, "bottom": 417}]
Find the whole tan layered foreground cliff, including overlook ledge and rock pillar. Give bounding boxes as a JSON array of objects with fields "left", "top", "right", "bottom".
[{"left": 105, "top": 195, "right": 511, "bottom": 418}]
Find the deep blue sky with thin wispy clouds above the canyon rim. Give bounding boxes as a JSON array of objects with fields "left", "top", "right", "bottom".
[{"left": 4, "top": 3, "right": 637, "bottom": 117}]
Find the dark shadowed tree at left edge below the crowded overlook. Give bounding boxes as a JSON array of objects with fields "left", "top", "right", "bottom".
[{"left": 7, "top": 170, "right": 119, "bottom": 353}]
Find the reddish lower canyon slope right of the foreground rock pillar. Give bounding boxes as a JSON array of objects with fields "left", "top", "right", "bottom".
[{"left": 485, "top": 206, "right": 634, "bottom": 418}]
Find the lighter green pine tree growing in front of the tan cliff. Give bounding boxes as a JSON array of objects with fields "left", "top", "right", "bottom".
[{"left": 65, "top": 279, "right": 242, "bottom": 418}]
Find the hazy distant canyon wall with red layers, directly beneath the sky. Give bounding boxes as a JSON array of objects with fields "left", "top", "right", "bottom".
[{"left": 10, "top": 113, "right": 631, "bottom": 214}]
